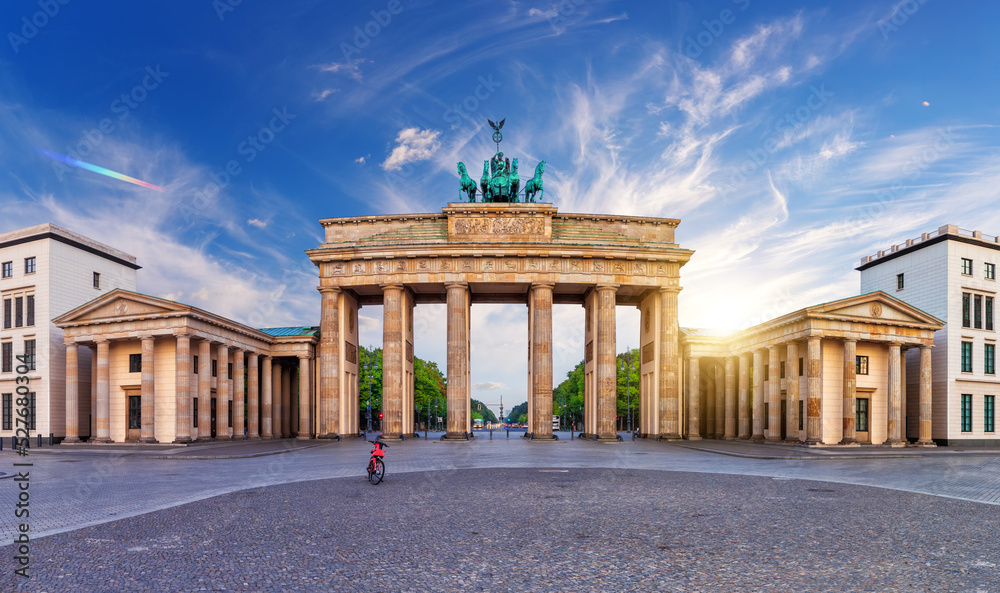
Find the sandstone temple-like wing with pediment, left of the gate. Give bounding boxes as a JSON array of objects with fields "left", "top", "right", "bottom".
[{"left": 54, "top": 289, "right": 319, "bottom": 443}]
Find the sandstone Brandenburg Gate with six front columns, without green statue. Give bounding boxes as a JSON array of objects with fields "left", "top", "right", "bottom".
[{"left": 307, "top": 204, "right": 693, "bottom": 439}]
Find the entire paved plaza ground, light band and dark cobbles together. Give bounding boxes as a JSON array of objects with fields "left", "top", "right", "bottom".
[{"left": 0, "top": 433, "right": 1000, "bottom": 591}]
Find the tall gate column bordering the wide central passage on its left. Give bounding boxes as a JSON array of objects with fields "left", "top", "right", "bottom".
[{"left": 444, "top": 283, "right": 470, "bottom": 439}]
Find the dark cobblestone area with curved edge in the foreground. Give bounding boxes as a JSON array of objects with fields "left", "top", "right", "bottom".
[{"left": 0, "top": 468, "right": 1000, "bottom": 593}]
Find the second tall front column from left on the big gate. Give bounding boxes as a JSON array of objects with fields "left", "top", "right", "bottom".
[{"left": 382, "top": 284, "right": 406, "bottom": 439}]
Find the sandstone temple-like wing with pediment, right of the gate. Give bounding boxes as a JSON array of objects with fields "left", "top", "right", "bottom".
[{"left": 680, "top": 292, "right": 944, "bottom": 446}]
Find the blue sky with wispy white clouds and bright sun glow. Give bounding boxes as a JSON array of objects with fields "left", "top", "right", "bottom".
[{"left": 0, "top": 0, "right": 1000, "bottom": 408}]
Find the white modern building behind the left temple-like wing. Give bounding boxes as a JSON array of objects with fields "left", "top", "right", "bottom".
[{"left": 0, "top": 224, "right": 139, "bottom": 438}]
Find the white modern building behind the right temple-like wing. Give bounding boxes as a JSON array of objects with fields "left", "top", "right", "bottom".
[{"left": 857, "top": 225, "right": 1000, "bottom": 445}]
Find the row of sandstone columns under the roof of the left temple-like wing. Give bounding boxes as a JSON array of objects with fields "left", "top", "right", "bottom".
[{"left": 64, "top": 333, "right": 313, "bottom": 443}]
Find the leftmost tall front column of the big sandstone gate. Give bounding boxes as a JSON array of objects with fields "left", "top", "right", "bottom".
[{"left": 320, "top": 286, "right": 341, "bottom": 439}]
